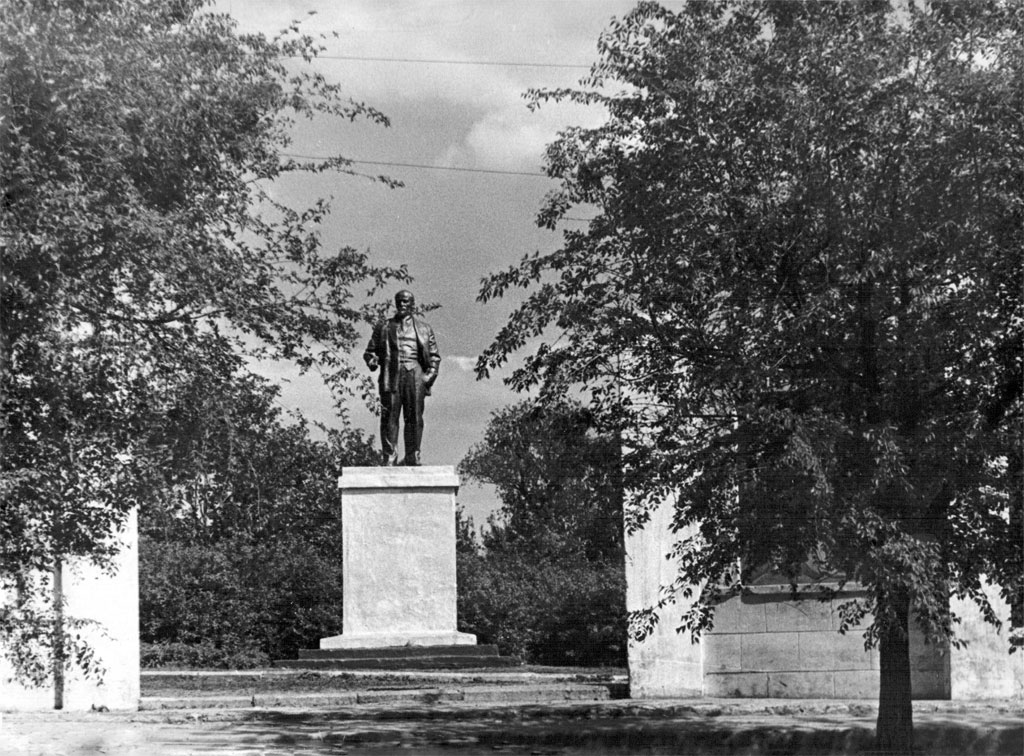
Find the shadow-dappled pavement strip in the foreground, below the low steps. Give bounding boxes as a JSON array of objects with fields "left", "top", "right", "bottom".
[{"left": 9, "top": 709, "right": 1024, "bottom": 756}]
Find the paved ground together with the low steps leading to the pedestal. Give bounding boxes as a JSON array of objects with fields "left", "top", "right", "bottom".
[{"left": 0, "top": 673, "right": 1024, "bottom": 756}]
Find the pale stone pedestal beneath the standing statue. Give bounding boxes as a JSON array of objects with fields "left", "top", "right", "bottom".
[{"left": 319, "top": 467, "right": 476, "bottom": 648}]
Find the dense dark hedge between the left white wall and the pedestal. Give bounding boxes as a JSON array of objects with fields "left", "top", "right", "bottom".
[{"left": 139, "top": 534, "right": 342, "bottom": 668}]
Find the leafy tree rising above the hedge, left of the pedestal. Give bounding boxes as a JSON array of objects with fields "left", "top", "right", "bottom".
[{"left": 140, "top": 356, "right": 378, "bottom": 549}]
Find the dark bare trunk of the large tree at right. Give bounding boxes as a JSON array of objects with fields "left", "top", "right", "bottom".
[{"left": 874, "top": 592, "right": 913, "bottom": 756}]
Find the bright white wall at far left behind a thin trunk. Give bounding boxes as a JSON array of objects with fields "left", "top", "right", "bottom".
[{"left": 0, "top": 511, "right": 139, "bottom": 711}]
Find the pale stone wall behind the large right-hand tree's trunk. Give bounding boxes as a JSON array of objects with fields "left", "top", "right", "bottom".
[{"left": 626, "top": 491, "right": 1011, "bottom": 701}]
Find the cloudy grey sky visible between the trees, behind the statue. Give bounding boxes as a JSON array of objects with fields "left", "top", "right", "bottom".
[{"left": 217, "top": 0, "right": 659, "bottom": 523}]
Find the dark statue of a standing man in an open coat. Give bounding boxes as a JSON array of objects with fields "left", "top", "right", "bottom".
[{"left": 362, "top": 290, "right": 441, "bottom": 467}]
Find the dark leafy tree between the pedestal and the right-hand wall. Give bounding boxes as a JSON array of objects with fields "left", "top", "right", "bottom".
[{"left": 458, "top": 402, "right": 626, "bottom": 665}]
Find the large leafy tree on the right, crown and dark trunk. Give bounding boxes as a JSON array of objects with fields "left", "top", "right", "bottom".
[{"left": 477, "top": 0, "right": 1024, "bottom": 752}]
